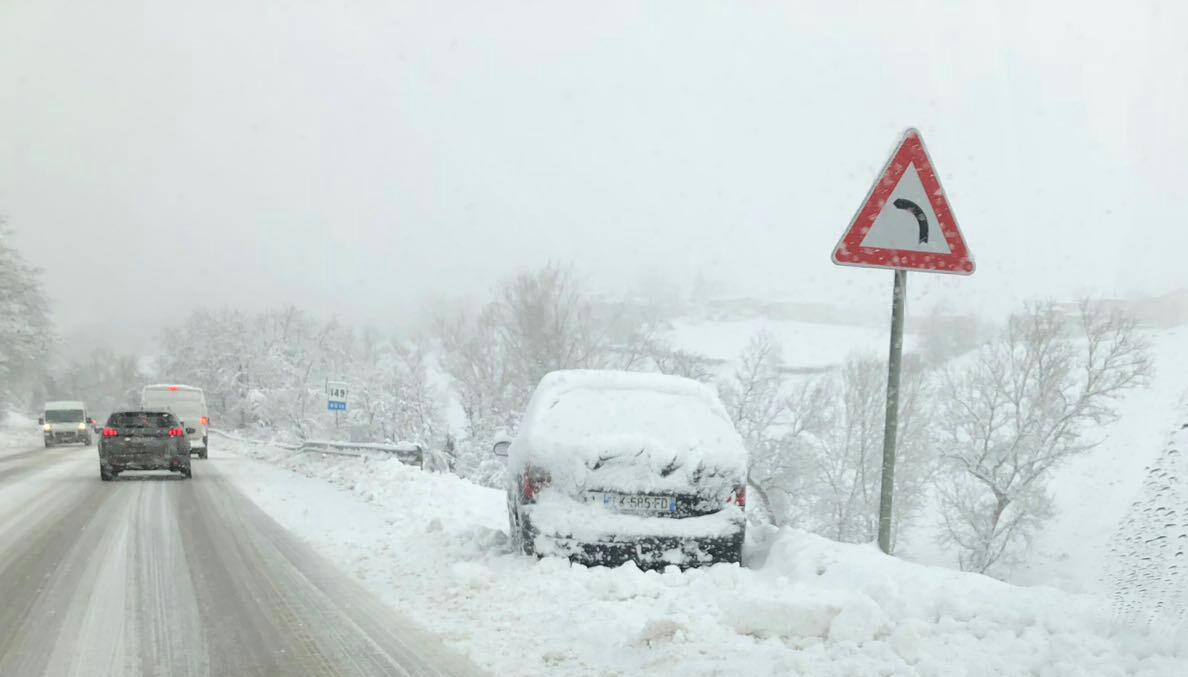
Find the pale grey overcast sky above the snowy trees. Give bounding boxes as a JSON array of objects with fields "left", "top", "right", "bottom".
[{"left": 0, "top": 0, "right": 1188, "bottom": 346}]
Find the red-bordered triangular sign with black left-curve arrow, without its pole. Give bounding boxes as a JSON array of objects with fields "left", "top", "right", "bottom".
[{"left": 833, "top": 129, "right": 974, "bottom": 276}]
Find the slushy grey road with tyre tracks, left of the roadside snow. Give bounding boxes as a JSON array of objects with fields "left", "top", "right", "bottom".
[{"left": 0, "top": 447, "right": 476, "bottom": 676}]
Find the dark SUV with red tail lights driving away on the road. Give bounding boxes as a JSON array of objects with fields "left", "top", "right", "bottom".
[{"left": 99, "top": 409, "right": 192, "bottom": 482}]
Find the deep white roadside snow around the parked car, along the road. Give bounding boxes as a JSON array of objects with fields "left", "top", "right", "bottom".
[{"left": 224, "top": 443, "right": 1188, "bottom": 677}]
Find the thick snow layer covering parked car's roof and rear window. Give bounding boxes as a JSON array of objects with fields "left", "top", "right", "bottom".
[{"left": 508, "top": 371, "right": 746, "bottom": 493}]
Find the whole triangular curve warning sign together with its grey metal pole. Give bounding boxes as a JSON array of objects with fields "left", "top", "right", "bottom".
[{"left": 833, "top": 129, "right": 974, "bottom": 553}]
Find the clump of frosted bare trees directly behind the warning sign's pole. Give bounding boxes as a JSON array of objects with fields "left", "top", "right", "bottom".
[{"left": 719, "top": 333, "right": 934, "bottom": 542}]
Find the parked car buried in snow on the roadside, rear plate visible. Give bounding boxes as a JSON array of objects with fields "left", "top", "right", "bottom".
[{"left": 507, "top": 371, "right": 747, "bottom": 568}]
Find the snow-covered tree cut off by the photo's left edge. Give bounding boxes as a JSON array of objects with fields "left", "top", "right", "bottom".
[{"left": 0, "top": 225, "right": 53, "bottom": 418}]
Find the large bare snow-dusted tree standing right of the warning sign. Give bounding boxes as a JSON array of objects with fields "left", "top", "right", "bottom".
[{"left": 937, "top": 303, "right": 1151, "bottom": 572}]
